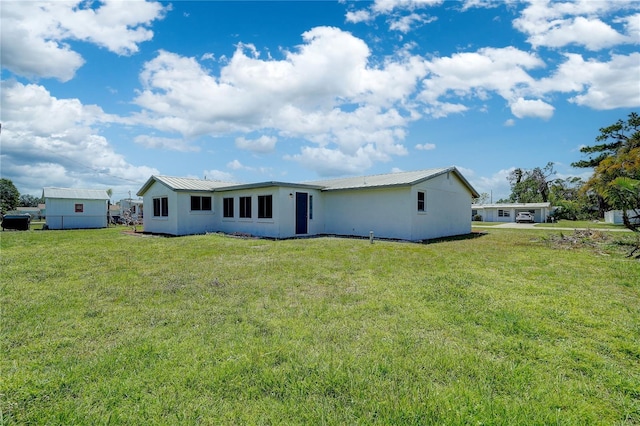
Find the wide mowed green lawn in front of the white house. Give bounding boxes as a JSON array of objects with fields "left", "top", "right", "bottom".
[{"left": 0, "top": 228, "right": 640, "bottom": 425}]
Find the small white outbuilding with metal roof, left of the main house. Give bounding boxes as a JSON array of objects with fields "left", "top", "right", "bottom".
[{"left": 42, "top": 188, "right": 109, "bottom": 229}]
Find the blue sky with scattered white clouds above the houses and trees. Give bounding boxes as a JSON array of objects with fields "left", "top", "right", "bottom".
[{"left": 0, "top": 0, "right": 640, "bottom": 201}]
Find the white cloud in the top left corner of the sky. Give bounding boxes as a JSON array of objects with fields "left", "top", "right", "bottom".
[{"left": 0, "top": 0, "right": 165, "bottom": 81}]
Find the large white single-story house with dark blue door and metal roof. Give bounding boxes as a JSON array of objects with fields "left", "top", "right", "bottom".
[{"left": 137, "top": 167, "right": 478, "bottom": 241}]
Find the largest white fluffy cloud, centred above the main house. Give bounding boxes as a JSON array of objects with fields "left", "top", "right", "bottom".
[{"left": 135, "top": 27, "right": 426, "bottom": 176}]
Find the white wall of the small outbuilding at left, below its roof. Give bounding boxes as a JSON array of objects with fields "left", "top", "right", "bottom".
[{"left": 45, "top": 198, "right": 108, "bottom": 229}]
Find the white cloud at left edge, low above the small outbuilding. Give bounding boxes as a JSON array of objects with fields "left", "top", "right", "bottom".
[{"left": 1, "top": 82, "right": 157, "bottom": 195}]
